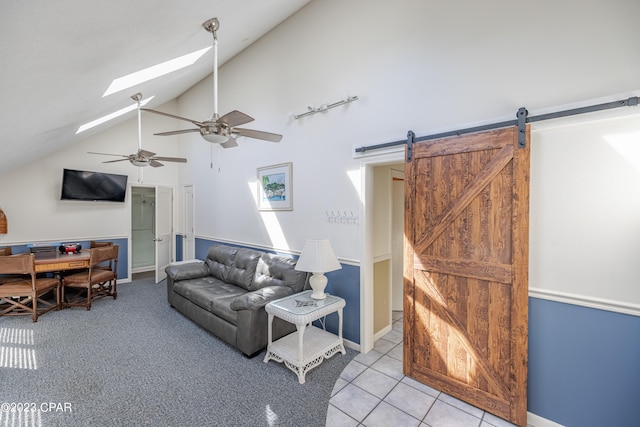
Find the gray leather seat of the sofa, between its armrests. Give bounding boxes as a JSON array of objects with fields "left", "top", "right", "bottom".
[{"left": 173, "top": 276, "right": 247, "bottom": 325}]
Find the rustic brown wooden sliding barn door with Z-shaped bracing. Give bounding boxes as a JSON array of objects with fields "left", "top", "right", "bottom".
[{"left": 403, "top": 127, "right": 529, "bottom": 426}]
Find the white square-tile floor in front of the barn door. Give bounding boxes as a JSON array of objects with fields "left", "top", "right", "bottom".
[{"left": 326, "top": 312, "right": 528, "bottom": 427}]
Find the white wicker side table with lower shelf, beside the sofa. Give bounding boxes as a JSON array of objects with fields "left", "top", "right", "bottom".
[{"left": 264, "top": 291, "right": 346, "bottom": 384}]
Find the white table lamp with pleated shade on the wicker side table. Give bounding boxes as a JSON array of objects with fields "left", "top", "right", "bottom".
[{"left": 296, "top": 239, "right": 342, "bottom": 299}]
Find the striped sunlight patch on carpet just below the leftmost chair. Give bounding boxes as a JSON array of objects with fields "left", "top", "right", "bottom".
[{"left": 0, "top": 328, "right": 38, "bottom": 369}]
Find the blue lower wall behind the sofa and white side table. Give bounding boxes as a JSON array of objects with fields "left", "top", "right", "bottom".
[{"left": 195, "top": 238, "right": 360, "bottom": 344}]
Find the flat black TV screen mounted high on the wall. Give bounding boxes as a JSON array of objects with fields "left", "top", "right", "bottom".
[{"left": 60, "top": 169, "right": 128, "bottom": 202}]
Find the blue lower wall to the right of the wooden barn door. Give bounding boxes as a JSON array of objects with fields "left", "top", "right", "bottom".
[{"left": 528, "top": 298, "right": 640, "bottom": 427}]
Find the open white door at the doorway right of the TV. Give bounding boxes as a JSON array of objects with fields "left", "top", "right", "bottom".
[{"left": 154, "top": 187, "right": 173, "bottom": 283}]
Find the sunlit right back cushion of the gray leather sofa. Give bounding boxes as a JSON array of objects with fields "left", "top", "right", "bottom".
[{"left": 249, "top": 253, "right": 307, "bottom": 293}]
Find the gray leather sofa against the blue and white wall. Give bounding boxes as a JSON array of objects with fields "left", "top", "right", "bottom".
[{"left": 165, "top": 245, "right": 307, "bottom": 357}]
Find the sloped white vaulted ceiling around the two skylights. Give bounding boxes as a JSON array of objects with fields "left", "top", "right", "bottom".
[{"left": 0, "top": 0, "right": 310, "bottom": 174}]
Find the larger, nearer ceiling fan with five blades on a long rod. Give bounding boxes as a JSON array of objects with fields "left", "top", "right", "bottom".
[{"left": 142, "top": 18, "right": 282, "bottom": 148}]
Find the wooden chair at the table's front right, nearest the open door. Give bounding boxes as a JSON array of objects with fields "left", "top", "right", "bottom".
[{"left": 62, "top": 245, "right": 118, "bottom": 310}]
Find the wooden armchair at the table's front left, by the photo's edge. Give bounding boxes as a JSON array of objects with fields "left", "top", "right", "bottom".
[{"left": 0, "top": 254, "right": 60, "bottom": 322}]
